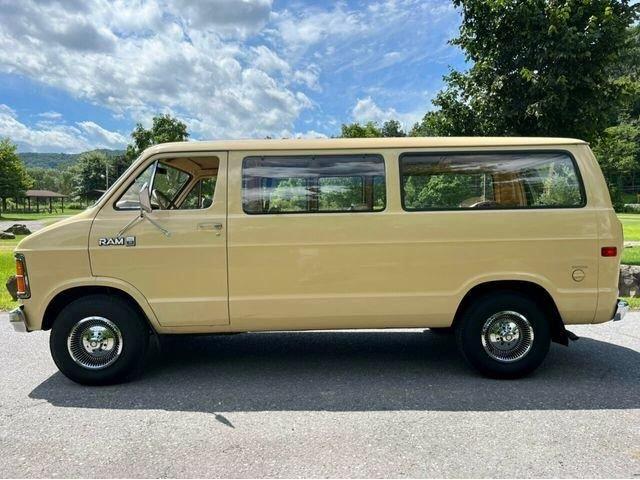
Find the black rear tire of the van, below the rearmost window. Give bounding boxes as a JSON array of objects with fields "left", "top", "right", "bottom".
[{"left": 456, "top": 292, "right": 551, "bottom": 379}]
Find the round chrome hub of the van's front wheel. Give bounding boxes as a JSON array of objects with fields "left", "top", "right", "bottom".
[{"left": 67, "top": 317, "right": 122, "bottom": 370}]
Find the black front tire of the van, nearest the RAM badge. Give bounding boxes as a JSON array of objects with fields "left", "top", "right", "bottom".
[{"left": 49, "top": 295, "right": 149, "bottom": 385}]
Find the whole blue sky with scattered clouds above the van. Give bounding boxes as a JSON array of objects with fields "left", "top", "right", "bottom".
[{"left": 0, "top": 0, "right": 464, "bottom": 152}]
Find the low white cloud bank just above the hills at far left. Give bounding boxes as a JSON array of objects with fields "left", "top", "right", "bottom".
[{"left": 0, "top": 104, "right": 127, "bottom": 153}]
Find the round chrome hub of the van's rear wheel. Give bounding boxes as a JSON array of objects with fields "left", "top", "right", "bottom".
[{"left": 482, "top": 311, "right": 533, "bottom": 363}]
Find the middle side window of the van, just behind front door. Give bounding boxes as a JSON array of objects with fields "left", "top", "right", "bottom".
[{"left": 242, "top": 155, "right": 386, "bottom": 214}]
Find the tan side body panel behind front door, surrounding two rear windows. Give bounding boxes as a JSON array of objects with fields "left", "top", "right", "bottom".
[{"left": 228, "top": 146, "right": 599, "bottom": 330}]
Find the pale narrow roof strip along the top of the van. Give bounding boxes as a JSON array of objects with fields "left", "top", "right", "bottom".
[{"left": 149, "top": 137, "right": 586, "bottom": 153}]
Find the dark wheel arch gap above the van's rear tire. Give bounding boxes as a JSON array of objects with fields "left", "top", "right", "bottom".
[{"left": 452, "top": 280, "right": 569, "bottom": 345}]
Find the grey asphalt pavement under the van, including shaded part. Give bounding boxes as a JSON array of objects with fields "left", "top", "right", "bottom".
[{"left": 0, "top": 313, "right": 640, "bottom": 477}]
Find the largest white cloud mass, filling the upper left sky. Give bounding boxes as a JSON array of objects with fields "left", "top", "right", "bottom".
[{"left": 0, "top": 0, "right": 312, "bottom": 140}]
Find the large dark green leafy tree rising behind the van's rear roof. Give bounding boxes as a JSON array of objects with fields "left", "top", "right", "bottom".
[{"left": 412, "top": 0, "right": 638, "bottom": 140}]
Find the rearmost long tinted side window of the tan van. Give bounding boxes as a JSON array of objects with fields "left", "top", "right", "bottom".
[{"left": 400, "top": 152, "right": 586, "bottom": 210}]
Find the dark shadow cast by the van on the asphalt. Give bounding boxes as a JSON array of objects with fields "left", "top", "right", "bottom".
[{"left": 29, "top": 331, "right": 640, "bottom": 412}]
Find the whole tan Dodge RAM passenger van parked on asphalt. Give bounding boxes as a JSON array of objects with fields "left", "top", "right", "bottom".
[{"left": 10, "top": 138, "right": 626, "bottom": 384}]
